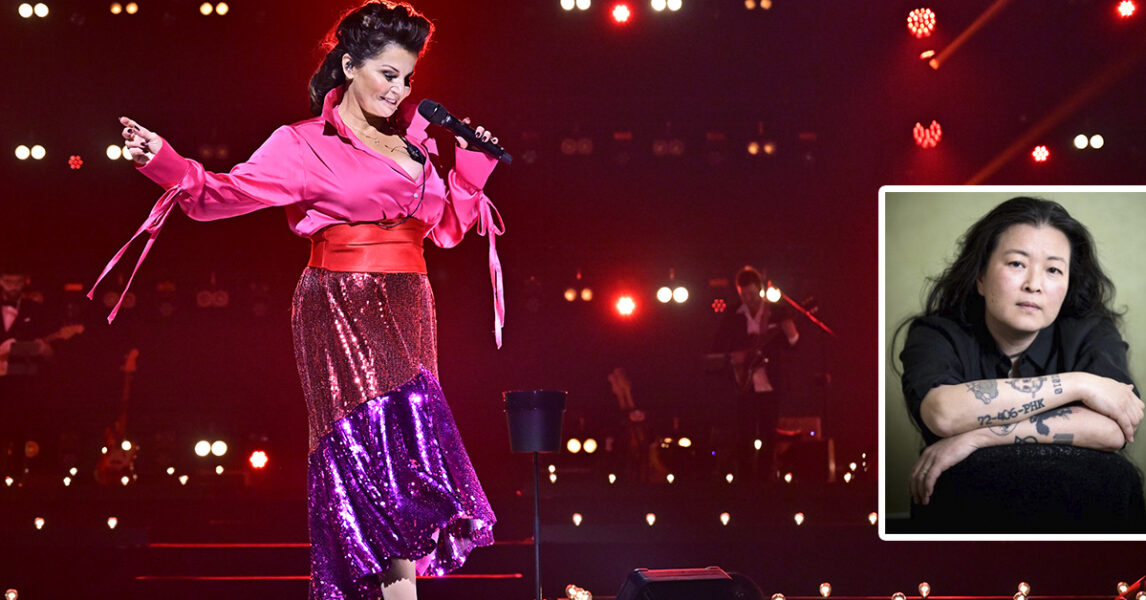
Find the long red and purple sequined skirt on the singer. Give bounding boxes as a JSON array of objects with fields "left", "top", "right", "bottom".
[{"left": 292, "top": 268, "right": 495, "bottom": 600}]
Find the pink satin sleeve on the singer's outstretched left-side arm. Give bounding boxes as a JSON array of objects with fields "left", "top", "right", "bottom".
[{"left": 139, "top": 126, "right": 306, "bottom": 221}]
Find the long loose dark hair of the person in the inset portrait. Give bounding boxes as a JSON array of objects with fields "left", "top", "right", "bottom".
[{"left": 924, "top": 197, "right": 1122, "bottom": 327}]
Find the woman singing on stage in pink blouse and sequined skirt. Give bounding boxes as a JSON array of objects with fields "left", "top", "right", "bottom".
[{"left": 91, "top": 1, "right": 503, "bottom": 600}]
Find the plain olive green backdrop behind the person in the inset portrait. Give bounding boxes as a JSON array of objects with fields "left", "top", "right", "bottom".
[{"left": 881, "top": 188, "right": 1146, "bottom": 514}]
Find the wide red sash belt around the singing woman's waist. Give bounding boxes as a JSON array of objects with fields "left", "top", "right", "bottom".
[{"left": 307, "top": 219, "right": 430, "bottom": 273}]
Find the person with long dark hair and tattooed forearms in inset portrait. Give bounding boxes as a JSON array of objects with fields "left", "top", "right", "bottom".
[{"left": 901, "top": 197, "right": 1146, "bottom": 531}]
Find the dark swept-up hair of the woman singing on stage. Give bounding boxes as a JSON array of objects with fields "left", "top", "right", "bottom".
[{"left": 309, "top": 0, "right": 433, "bottom": 115}]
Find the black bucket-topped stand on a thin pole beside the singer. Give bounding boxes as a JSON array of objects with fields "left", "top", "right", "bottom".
[{"left": 504, "top": 389, "right": 565, "bottom": 600}]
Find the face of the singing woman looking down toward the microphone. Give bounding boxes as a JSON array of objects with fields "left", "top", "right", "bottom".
[{"left": 343, "top": 44, "right": 418, "bottom": 118}]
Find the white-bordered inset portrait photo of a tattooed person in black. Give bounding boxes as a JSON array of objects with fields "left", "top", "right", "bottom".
[{"left": 879, "top": 187, "right": 1146, "bottom": 540}]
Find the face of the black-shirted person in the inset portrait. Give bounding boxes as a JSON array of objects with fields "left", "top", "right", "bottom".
[{"left": 976, "top": 224, "right": 1070, "bottom": 354}]
